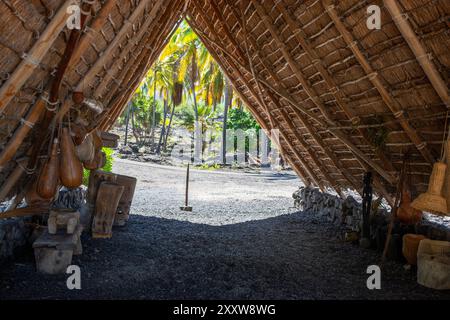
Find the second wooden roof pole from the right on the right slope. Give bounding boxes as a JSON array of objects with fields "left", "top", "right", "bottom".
[{"left": 322, "top": 0, "right": 434, "bottom": 164}]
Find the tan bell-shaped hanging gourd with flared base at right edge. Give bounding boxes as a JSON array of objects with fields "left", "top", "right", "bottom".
[{"left": 411, "top": 162, "right": 448, "bottom": 215}]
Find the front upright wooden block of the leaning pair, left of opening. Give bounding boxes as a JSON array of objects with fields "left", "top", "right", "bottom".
[{"left": 92, "top": 181, "right": 124, "bottom": 239}]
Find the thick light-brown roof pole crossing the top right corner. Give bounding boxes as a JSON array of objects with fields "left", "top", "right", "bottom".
[{"left": 383, "top": 0, "right": 450, "bottom": 108}]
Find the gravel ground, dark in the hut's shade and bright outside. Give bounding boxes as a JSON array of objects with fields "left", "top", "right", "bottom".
[{"left": 0, "top": 160, "right": 450, "bottom": 299}]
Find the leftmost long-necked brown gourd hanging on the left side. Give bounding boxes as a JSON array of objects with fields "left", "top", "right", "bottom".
[{"left": 36, "top": 138, "right": 59, "bottom": 200}]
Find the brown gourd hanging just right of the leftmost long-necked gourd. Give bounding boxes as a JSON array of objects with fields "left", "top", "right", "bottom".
[{"left": 59, "top": 128, "right": 83, "bottom": 188}]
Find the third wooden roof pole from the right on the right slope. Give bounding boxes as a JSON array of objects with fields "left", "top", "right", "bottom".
[{"left": 275, "top": 0, "right": 396, "bottom": 172}]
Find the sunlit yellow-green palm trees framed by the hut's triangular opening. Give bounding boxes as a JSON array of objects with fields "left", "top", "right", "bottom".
[{"left": 116, "top": 21, "right": 260, "bottom": 152}]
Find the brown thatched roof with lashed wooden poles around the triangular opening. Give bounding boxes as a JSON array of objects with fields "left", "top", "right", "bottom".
[{"left": 0, "top": 0, "right": 450, "bottom": 204}]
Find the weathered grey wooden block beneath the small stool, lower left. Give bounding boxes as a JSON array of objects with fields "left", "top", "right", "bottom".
[{"left": 33, "top": 225, "right": 83, "bottom": 274}]
